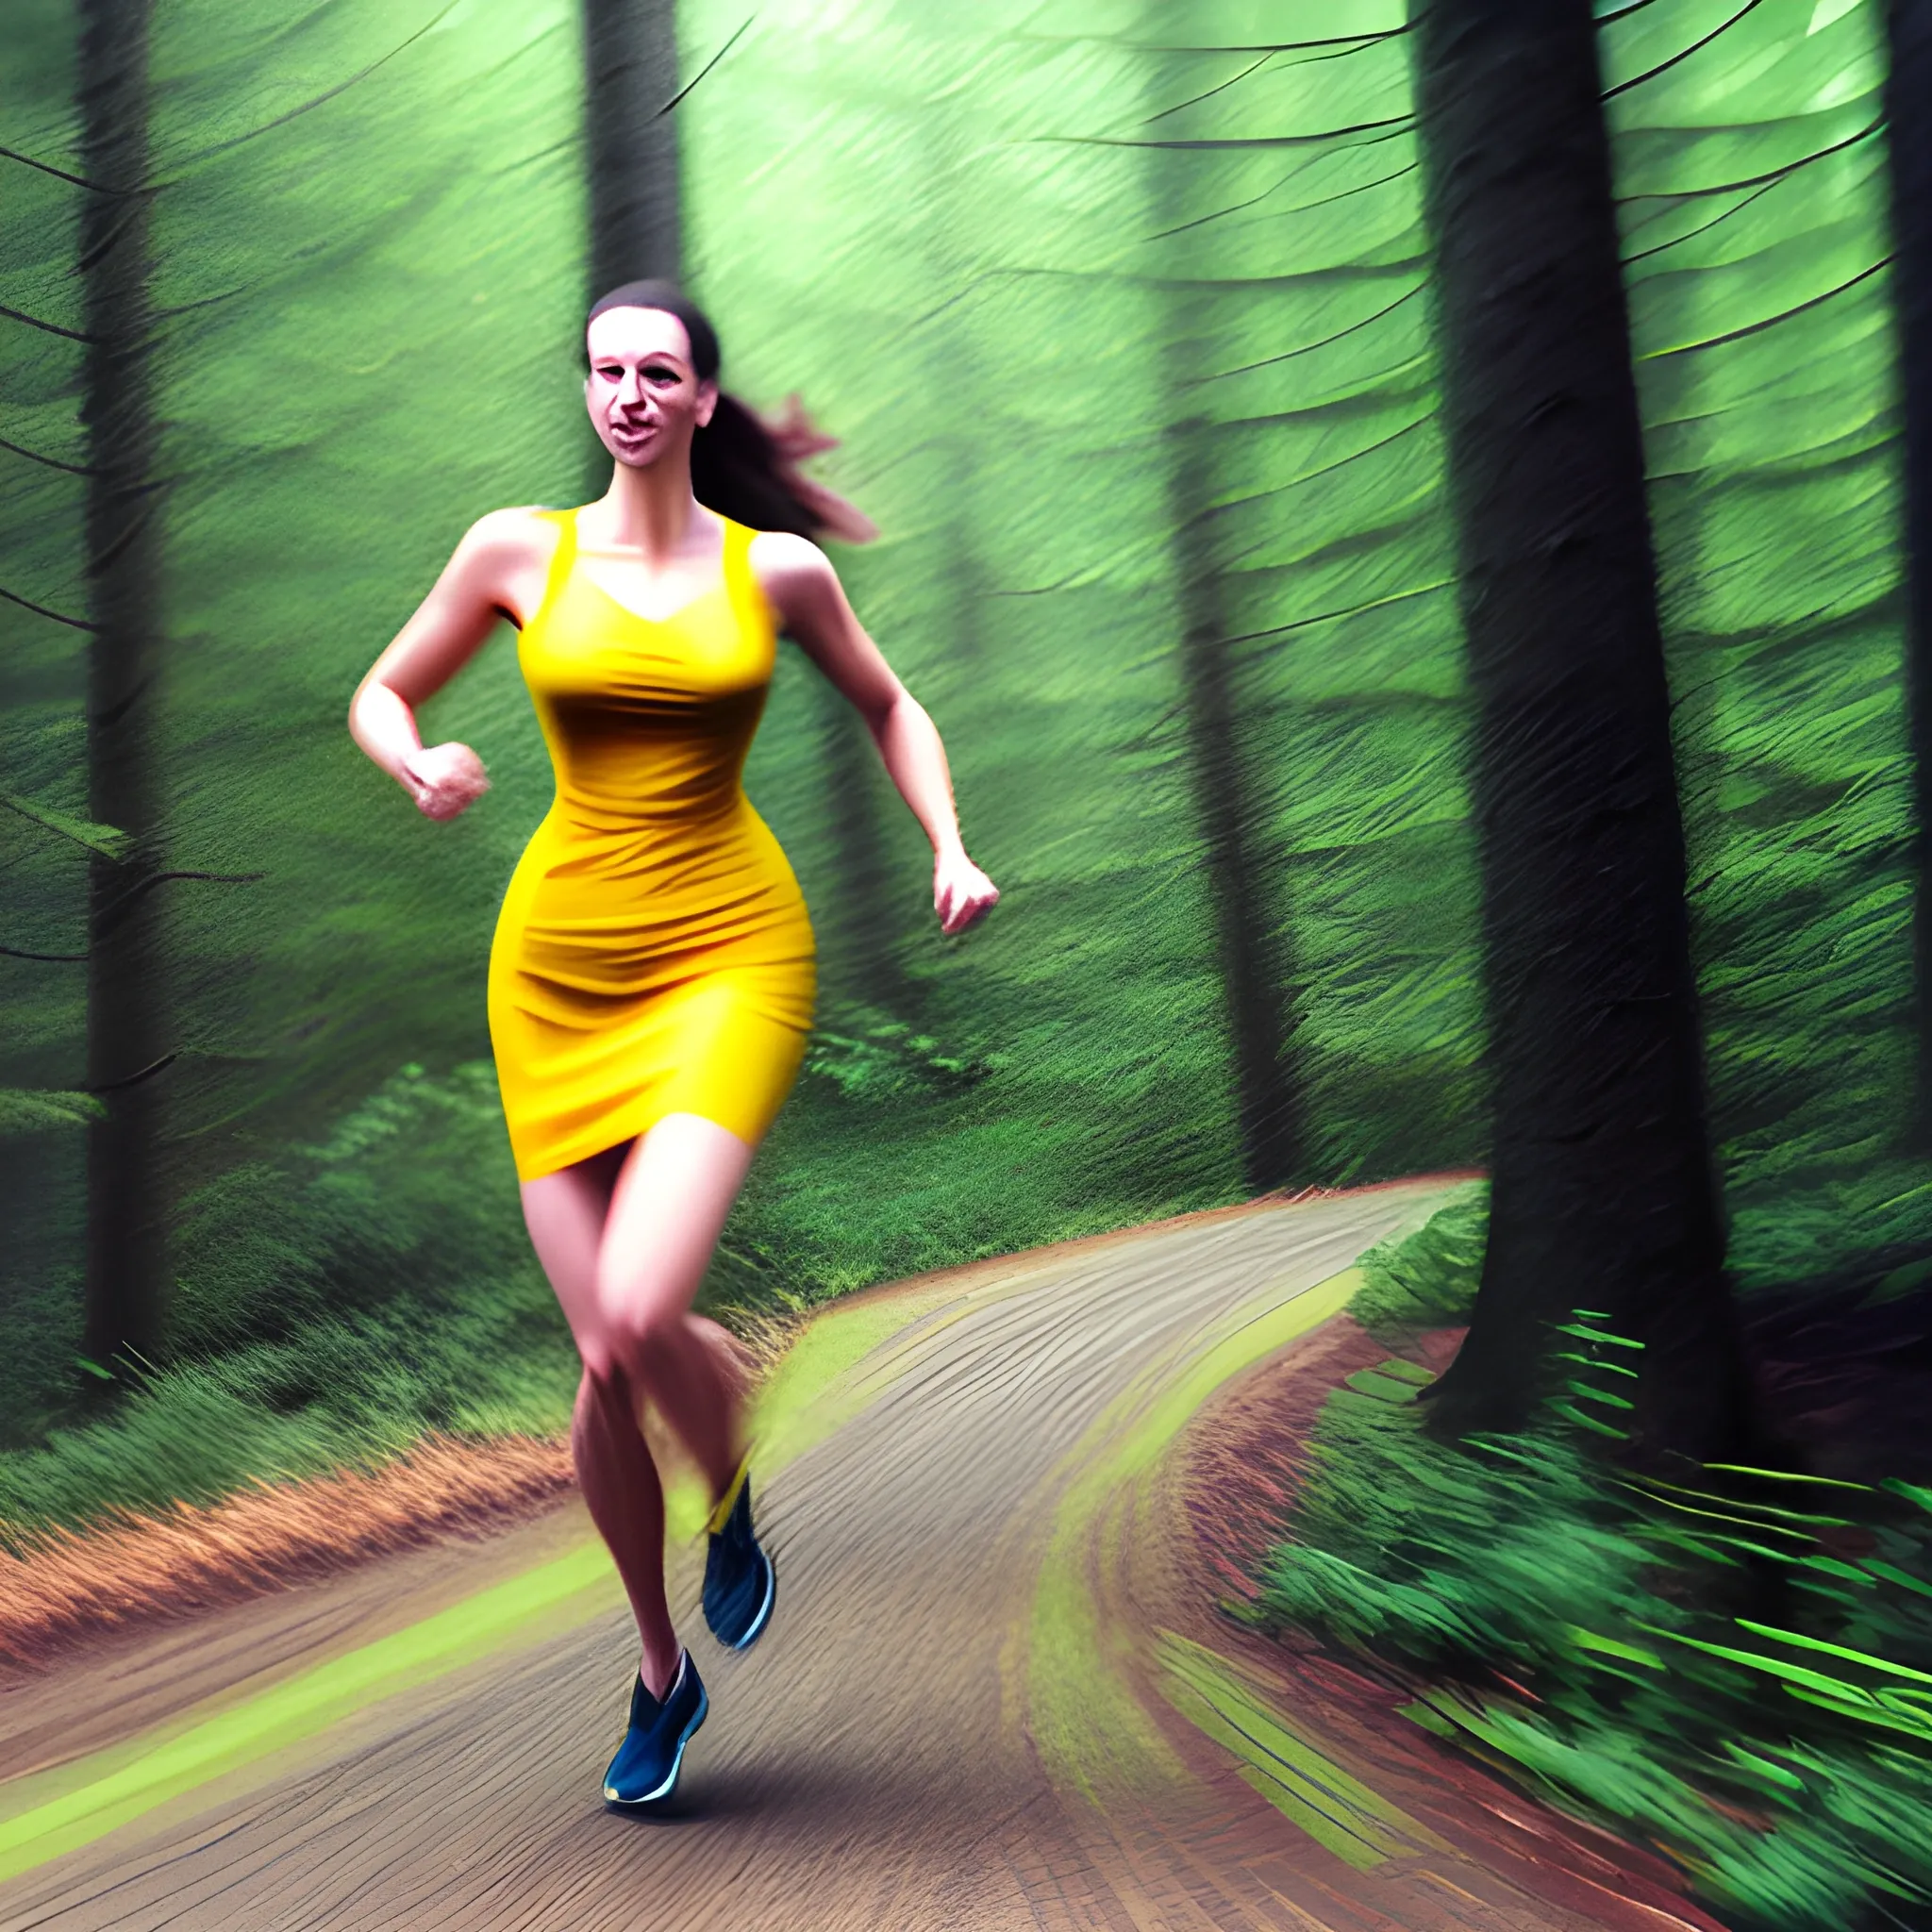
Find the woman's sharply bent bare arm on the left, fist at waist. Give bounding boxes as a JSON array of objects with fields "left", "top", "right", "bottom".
[{"left": 350, "top": 510, "right": 547, "bottom": 819}]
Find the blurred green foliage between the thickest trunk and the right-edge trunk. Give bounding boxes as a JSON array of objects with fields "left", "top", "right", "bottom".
[{"left": 1600, "top": 0, "right": 1932, "bottom": 1289}]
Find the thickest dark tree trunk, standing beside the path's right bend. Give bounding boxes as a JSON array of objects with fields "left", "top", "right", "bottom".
[{"left": 1414, "top": 0, "right": 1744, "bottom": 1460}]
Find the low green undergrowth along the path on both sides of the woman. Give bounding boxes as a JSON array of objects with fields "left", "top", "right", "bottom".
[{"left": 0, "top": 1007, "right": 1196, "bottom": 1547}]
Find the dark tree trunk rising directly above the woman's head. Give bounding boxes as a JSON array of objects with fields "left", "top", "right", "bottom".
[{"left": 583, "top": 0, "right": 684, "bottom": 301}]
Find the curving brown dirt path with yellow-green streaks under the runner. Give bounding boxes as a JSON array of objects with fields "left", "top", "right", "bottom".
[{"left": 0, "top": 1189, "right": 1707, "bottom": 1932}]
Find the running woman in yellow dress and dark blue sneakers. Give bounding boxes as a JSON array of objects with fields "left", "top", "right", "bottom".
[{"left": 350, "top": 282, "right": 999, "bottom": 1805}]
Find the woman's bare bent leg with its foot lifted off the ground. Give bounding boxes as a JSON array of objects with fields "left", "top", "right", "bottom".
[{"left": 597, "top": 1113, "right": 756, "bottom": 1501}]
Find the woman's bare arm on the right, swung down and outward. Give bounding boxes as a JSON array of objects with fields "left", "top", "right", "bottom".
[{"left": 752, "top": 531, "right": 999, "bottom": 933}]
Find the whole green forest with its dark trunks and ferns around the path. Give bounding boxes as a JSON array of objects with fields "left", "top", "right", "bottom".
[{"left": 0, "top": 0, "right": 1932, "bottom": 1928}]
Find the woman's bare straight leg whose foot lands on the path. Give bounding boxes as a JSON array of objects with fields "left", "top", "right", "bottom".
[{"left": 524, "top": 1148, "right": 680, "bottom": 1696}]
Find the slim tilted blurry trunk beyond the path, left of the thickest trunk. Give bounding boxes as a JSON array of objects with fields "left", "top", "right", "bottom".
[{"left": 1167, "top": 421, "right": 1302, "bottom": 1194}]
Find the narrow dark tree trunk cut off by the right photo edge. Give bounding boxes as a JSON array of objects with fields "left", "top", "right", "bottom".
[{"left": 1886, "top": 0, "right": 1932, "bottom": 1148}]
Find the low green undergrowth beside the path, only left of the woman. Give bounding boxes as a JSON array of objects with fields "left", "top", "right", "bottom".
[{"left": 0, "top": 1064, "right": 577, "bottom": 1530}]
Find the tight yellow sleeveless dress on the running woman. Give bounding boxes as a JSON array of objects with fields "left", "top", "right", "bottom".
[{"left": 489, "top": 510, "right": 815, "bottom": 1180}]
